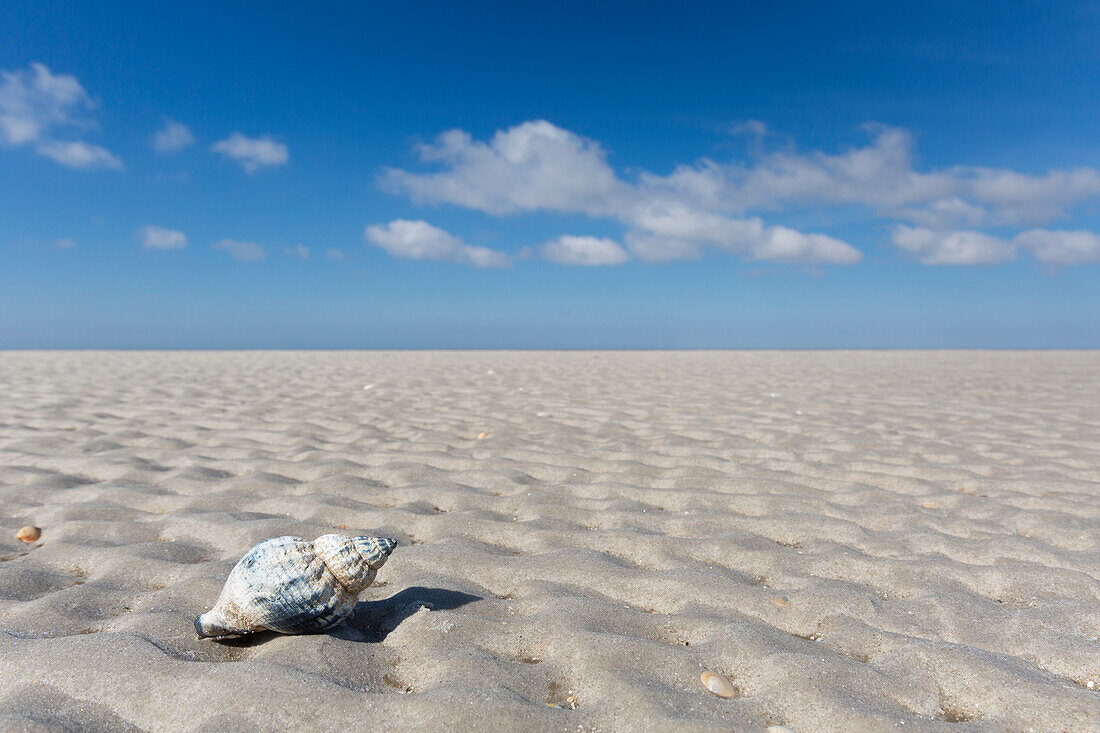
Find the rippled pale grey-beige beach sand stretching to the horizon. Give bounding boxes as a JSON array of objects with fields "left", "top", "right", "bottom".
[{"left": 0, "top": 352, "right": 1100, "bottom": 733}]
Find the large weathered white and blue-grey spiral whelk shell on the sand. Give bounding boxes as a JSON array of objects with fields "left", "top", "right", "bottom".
[{"left": 195, "top": 535, "right": 397, "bottom": 636}]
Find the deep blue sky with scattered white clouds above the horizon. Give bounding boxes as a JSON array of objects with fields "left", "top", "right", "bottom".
[{"left": 0, "top": 0, "right": 1100, "bottom": 348}]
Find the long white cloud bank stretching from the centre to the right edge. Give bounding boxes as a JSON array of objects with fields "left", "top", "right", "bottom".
[{"left": 380, "top": 120, "right": 1100, "bottom": 264}]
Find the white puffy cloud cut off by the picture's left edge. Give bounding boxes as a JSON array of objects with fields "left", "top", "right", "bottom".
[{"left": 0, "top": 63, "right": 122, "bottom": 169}]
